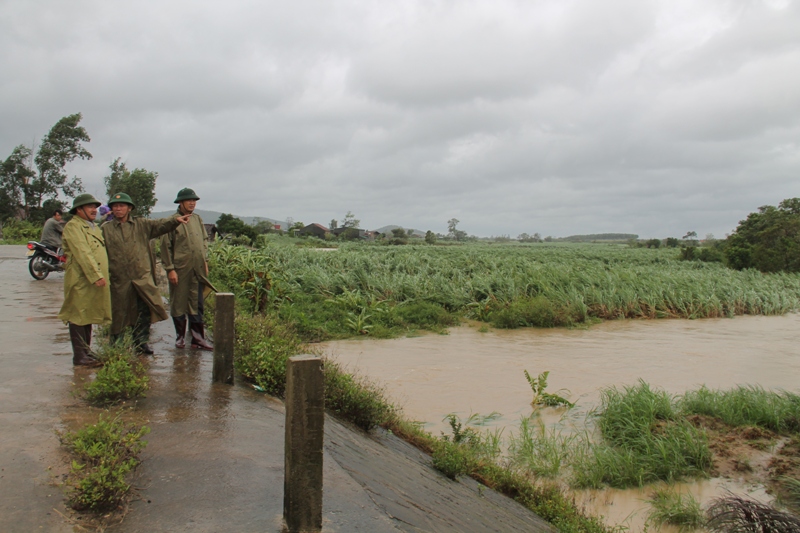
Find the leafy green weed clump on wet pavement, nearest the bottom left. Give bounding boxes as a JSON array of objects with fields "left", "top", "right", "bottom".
[{"left": 59, "top": 416, "right": 150, "bottom": 513}]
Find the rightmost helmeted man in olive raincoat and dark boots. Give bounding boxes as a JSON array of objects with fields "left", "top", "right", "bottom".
[{"left": 161, "top": 188, "right": 214, "bottom": 350}]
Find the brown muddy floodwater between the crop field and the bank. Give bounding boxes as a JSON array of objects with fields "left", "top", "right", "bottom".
[{"left": 325, "top": 314, "right": 800, "bottom": 531}]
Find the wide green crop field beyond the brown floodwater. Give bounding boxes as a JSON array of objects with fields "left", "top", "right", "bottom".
[{"left": 205, "top": 241, "right": 800, "bottom": 340}]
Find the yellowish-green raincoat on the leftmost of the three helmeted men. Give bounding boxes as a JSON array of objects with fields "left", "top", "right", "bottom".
[{"left": 58, "top": 216, "right": 111, "bottom": 326}]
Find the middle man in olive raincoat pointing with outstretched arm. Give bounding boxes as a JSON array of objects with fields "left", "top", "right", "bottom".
[{"left": 102, "top": 192, "right": 191, "bottom": 354}]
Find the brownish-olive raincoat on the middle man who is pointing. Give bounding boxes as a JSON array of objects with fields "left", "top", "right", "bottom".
[{"left": 102, "top": 215, "right": 180, "bottom": 335}]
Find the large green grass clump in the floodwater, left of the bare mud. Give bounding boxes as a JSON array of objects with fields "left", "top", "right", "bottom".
[{"left": 573, "top": 381, "right": 712, "bottom": 488}]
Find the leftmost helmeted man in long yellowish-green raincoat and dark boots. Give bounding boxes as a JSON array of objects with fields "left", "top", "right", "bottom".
[{"left": 57, "top": 194, "right": 111, "bottom": 366}]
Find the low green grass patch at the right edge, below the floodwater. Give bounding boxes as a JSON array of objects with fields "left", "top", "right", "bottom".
[{"left": 679, "top": 385, "right": 800, "bottom": 433}]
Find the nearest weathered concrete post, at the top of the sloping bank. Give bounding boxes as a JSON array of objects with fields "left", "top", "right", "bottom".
[{"left": 283, "top": 355, "right": 325, "bottom": 533}]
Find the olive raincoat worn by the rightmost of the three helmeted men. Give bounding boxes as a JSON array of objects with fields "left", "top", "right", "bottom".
[{"left": 161, "top": 210, "right": 216, "bottom": 317}]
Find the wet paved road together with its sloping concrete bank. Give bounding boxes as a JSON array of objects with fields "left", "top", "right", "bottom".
[{"left": 0, "top": 246, "right": 550, "bottom": 533}]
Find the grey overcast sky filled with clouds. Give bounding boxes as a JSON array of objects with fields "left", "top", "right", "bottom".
[{"left": 0, "top": 0, "right": 800, "bottom": 237}]
